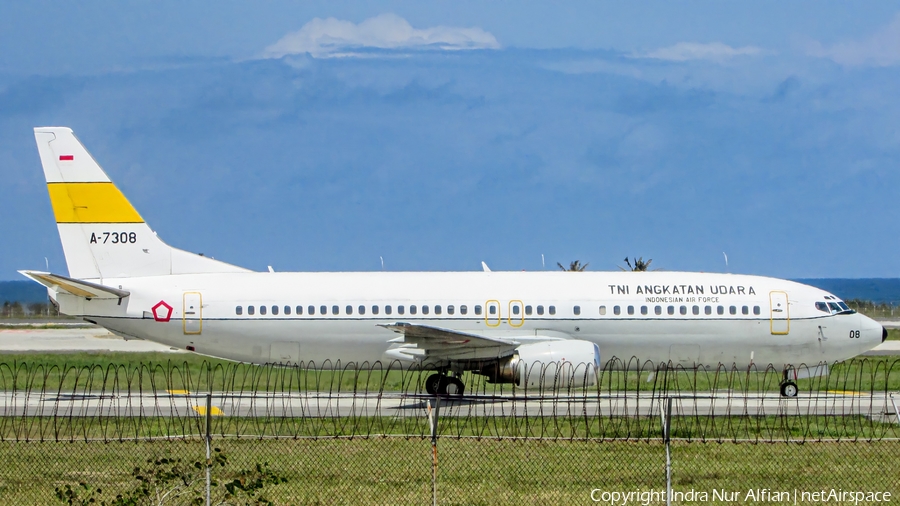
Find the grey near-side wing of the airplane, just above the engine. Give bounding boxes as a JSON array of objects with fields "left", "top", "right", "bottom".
[{"left": 379, "top": 322, "right": 521, "bottom": 361}]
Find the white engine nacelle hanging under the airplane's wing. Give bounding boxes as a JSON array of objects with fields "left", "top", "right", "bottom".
[{"left": 479, "top": 340, "right": 600, "bottom": 389}]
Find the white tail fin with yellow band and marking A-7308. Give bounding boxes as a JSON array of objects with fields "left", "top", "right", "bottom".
[{"left": 29, "top": 127, "right": 247, "bottom": 282}]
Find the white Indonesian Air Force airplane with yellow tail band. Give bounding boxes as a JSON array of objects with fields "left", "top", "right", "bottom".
[{"left": 19, "top": 127, "right": 887, "bottom": 396}]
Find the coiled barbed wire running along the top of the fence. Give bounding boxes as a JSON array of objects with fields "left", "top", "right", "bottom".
[{"left": 0, "top": 357, "right": 900, "bottom": 442}]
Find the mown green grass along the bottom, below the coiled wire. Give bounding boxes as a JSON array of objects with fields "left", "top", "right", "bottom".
[{"left": 0, "top": 437, "right": 900, "bottom": 505}]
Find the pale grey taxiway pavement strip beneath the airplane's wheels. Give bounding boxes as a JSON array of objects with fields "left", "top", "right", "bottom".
[{"left": 0, "top": 391, "right": 900, "bottom": 423}]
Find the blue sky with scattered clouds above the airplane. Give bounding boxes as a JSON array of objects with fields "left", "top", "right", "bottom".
[{"left": 0, "top": 2, "right": 900, "bottom": 279}]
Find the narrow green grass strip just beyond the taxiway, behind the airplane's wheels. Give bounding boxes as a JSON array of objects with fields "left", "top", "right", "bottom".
[{"left": 0, "top": 352, "right": 900, "bottom": 395}]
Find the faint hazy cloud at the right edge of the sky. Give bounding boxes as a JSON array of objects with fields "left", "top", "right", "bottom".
[{"left": 807, "top": 14, "right": 900, "bottom": 67}]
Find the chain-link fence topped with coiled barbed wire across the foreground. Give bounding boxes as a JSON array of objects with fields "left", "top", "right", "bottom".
[{"left": 0, "top": 358, "right": 900, "bottom": 504}]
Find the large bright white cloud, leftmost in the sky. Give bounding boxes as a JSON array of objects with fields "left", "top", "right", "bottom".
[{"left": 263, "top": 14, "right": 500, "bottom": 58}]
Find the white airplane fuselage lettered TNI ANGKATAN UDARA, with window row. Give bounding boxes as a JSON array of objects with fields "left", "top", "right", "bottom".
[{"left": 52, "top": 271, "right": 883, "bottom": 368}]
